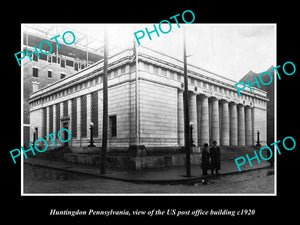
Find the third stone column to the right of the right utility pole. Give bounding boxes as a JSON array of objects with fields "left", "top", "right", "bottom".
[{"left": 211, "top": 98, "right": 220, "bottom": 144}]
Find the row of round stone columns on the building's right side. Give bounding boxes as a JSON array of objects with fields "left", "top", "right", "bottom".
[{"left": 178, "top": 90, "right": 254, "bottom": 146}]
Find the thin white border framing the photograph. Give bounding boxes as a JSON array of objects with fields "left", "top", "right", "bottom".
[{"left": 21, "top": 23, "right": 278, "bottom": 196}]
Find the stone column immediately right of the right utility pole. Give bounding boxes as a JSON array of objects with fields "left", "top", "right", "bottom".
[{"left": 189, "top": 92, "right": 198, "bottom": 146}]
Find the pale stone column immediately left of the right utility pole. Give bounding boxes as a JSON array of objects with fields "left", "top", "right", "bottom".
[{"left": 177, "top": 89, "right": 184, "bottom": 146}]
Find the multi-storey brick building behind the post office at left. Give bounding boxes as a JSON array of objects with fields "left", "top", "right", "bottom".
[{"left": 22, "top": 25, "right": 103, "bottom": 146}]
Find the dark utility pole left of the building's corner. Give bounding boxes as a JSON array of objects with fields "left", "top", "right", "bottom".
[{"left": 100, "top": 27, "right": 108, "bottom": 174}]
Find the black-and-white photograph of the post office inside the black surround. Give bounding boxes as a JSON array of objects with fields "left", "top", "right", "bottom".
[{"left": 21, "top": 23, "right": 276, "bottom": 195}]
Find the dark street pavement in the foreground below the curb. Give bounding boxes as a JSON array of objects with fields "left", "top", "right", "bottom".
[{"left": 24, "top": 164, "right": 274, "bottom": 194}]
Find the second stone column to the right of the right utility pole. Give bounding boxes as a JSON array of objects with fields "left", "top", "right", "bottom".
[{"left": 200, "top": 95, "right": 209, "bottom": 146}]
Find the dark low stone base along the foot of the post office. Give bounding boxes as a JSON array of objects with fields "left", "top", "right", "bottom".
[{"left": 64, "top": 146, "right": 259, "bottom": 170}]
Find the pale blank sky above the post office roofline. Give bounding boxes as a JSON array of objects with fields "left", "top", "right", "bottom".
[{"left": 23, "top": 23, "right": 276, "bottom": 81}]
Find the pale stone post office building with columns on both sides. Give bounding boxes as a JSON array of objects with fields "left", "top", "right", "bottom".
[{"left": 29, "top": 47, "right": 268, "bottom": 151}]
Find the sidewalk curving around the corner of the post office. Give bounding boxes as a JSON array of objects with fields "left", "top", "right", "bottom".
[{"left": 24, "top": 157, "right": 270, "bottom": 184}]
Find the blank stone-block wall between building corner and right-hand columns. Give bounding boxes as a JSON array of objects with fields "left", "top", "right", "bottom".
[{"left": 140, "top": 81, "right": 177, "bottom": 147}]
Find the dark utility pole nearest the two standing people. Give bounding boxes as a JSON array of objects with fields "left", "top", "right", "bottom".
[{"left": 183, "top": 26, "right": 191, "bottom": 177}]
